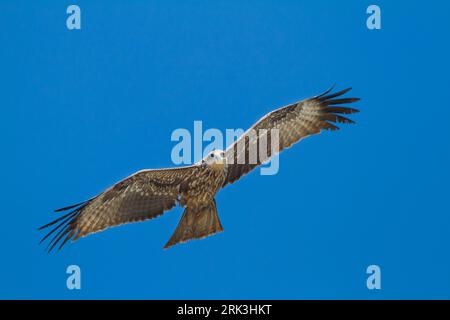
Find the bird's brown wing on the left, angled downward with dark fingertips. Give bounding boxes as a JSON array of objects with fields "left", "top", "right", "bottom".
[{"left": 39, "top": 166, "right": 198, "bottom": 251}]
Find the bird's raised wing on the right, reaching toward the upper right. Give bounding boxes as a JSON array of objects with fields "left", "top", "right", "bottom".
[{"left": 223, "top": 88, "right": 359, "bottom": 186}]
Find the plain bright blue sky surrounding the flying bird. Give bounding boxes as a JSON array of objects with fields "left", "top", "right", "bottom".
[{"left": 0, "top": 0, "right": 450, "bottom": 299}]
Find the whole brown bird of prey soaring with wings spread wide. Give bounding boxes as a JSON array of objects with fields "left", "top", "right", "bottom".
[{"left": 39, "top": 88, "right": 359, "bottom": 251}]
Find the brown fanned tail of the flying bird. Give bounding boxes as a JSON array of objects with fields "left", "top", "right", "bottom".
[{"left": 164, "top": 200, "right": 223, "bottom": 249}]
